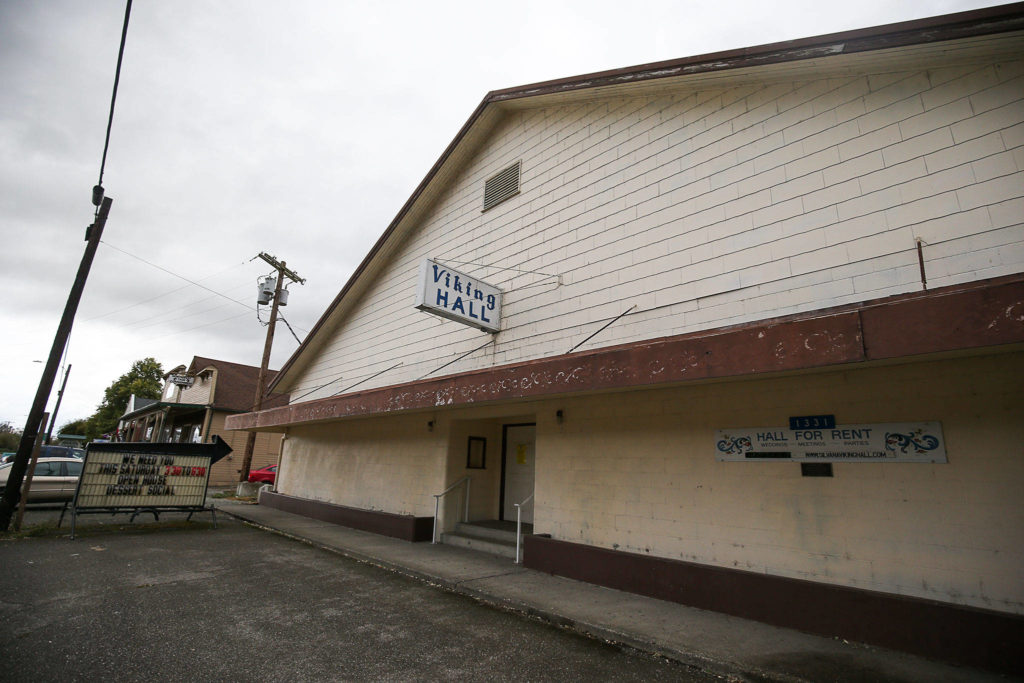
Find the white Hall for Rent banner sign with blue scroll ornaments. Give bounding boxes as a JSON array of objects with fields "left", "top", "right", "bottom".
[{"left": 715, "top": 422, "right": 948, "bottom": 463}]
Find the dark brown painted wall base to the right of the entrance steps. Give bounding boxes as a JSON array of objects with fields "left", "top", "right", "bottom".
[{"left": 523, "top": 536, "right": 1024, "bottom": 675}]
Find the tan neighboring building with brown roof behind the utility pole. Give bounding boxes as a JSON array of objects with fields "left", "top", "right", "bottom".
[{"left": 118, "top": 356, "right": 288, "bottom": 485}]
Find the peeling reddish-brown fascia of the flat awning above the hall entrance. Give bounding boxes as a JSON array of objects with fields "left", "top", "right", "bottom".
[{"left": 225, "top": 273, "right": 1024, "bottom": 430}]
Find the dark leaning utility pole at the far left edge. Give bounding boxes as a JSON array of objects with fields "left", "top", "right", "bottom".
[{"left": 0, "top": 194, "right": 114, "bottom": 531}]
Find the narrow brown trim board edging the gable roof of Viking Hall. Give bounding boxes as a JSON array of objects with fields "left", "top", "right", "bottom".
[{"left": 267, "top": 2, "right": 1024, "bottom": 392}]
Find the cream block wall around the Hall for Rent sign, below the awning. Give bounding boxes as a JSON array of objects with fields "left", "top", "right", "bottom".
[{"left": 536, "top": 353, "right": 1024, "bottom": 613}]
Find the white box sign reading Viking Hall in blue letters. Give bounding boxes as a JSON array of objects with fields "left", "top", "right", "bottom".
[{"left": 416, "top": 258, "right": 502, "bottom": 333}]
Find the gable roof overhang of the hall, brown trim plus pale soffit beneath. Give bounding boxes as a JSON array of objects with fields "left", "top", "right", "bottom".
[{"left": 269, "top": 2, "right": 1024, "bottom": 390}]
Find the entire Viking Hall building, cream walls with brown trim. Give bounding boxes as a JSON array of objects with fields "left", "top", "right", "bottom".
[{"left": 227, "top": 4, "right": 1024, "bottom": 670}]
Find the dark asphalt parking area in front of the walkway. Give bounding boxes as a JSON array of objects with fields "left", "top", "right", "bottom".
[{"left": 0, "top": 515, "right": 717, "bottom": 683}]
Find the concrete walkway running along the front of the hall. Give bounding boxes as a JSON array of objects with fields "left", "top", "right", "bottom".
[{"left": 214, "top": 500, "right": 1008, "bottom": 683}]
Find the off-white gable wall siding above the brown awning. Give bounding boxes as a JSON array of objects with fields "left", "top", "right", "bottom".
[{"left": 292, "top": 61, "right": 1024, "bottom": 400}]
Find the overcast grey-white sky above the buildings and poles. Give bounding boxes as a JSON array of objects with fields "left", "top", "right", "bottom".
[{"left": 0, "top": 0, "right": 999, "bottom": 428}]
